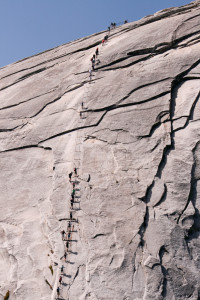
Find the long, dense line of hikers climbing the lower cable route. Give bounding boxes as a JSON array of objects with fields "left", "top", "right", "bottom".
[{"left": 56, "top": 167, "right": 78, "bottom": 297}]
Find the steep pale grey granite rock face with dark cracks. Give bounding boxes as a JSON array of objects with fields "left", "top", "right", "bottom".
[{"left": 0, "top": 1, "right": 200, "bottom": 300}]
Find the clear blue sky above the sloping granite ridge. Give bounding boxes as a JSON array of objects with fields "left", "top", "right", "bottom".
[{"left": 0, "top": 0, "right": 191, "bottom": 67}]
